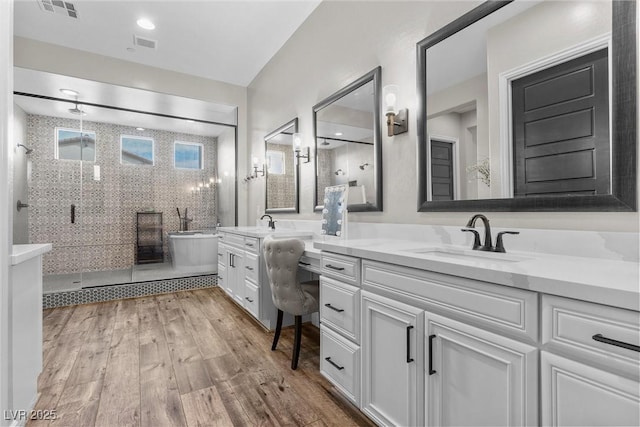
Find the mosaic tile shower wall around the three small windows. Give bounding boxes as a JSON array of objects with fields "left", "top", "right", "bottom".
[{"left": 27, "top": 115, "right": 217, "bottom": 275}]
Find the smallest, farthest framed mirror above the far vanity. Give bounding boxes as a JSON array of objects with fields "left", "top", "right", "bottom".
[{"left": 264, "top": 118, "right": 300, "bottom": 213}]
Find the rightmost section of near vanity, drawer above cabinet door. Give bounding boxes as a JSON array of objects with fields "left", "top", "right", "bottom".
[{"left": 541, "top": 295, "right": 640, "bottom": 426}]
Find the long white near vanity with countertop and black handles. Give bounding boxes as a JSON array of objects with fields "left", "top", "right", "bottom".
[{"left": 314, "top": 239, "right": 640, "bottom": 426}]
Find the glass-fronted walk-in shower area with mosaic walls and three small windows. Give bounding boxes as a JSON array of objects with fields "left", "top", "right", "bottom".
[{"left": 14, "top": 68, "right": 237, "bottom": 293}]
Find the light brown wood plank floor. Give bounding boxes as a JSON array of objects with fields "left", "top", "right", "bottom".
[{"left": 27, "top": 288, "right": 372, "bottom": 427}]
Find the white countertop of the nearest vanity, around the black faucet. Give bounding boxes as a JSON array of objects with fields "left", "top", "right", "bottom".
[{"left": 313, "top": 239, "right": 640, "bottom": 311}]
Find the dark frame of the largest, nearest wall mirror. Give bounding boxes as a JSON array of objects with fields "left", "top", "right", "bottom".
[{"left": 416, "top": 0, "right": 638, "bottom": 212}]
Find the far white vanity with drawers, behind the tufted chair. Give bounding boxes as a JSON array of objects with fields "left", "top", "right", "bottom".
[{"left": 218, "top": 227, "right": 320, "bottom": 329}]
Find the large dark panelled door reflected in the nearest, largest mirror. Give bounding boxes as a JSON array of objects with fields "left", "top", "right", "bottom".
[{"left": 511, "top": 49, "right": 610, "bottom": 197}]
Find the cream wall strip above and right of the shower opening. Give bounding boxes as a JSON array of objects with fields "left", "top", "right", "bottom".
[{"left": 14, "top": 37, "right": 247, "bottom": 224}]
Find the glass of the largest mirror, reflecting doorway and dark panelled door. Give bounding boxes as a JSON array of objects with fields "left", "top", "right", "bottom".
[{"left": 420, "top": 0, "right": 612, "bottom": 200}]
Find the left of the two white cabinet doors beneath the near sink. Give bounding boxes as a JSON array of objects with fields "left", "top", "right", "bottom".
[{"left": 361, "top": 291, "right": 424, "bottom": 426}]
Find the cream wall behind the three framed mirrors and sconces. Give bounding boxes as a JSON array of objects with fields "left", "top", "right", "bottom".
[{"left": 244, "top": 1, "right": 639, "bottom": 231}]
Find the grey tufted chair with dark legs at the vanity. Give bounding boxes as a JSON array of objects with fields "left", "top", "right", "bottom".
[{"left": 262, "top": 236, "right": 320, "bottom": 369}]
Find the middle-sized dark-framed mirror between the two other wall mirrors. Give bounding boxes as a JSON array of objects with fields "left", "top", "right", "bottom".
[{"left": 313, "top": 67, "right": 382, "bottom": 212}]
